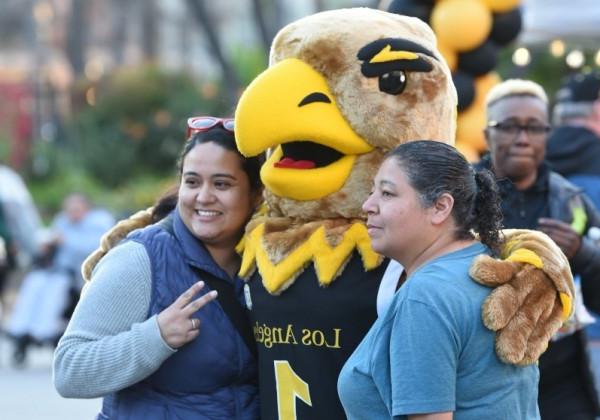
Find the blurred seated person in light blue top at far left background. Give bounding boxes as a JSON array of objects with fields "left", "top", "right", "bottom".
[{"left": 6, "top": 193, "right": 114, "bottom": 365}]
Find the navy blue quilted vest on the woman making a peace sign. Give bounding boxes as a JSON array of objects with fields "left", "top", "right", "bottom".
[{"left": 98, "top": 210, "right": 259, "bottom": 420}]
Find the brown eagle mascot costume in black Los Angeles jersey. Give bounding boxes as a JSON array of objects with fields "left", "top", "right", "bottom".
[{"left": 83, "top": 8, "right": 573, "bottom": 420}]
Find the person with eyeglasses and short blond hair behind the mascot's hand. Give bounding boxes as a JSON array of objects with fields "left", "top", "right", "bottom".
[{"left": 478, "top": 79, "right": 600, "bottom": 420}]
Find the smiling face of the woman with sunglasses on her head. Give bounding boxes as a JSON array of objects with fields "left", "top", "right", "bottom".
[{"left": 178, "top": 142, "right": 257, "bottom": 249}]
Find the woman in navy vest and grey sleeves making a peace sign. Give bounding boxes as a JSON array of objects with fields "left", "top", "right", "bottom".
[{"left": 54, "top": 117, "right": 262, "bottom": 420}]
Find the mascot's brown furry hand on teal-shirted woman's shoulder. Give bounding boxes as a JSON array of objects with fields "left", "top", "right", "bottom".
[{"left": 470, "top": 229, "right": 575, "bottom": 365}]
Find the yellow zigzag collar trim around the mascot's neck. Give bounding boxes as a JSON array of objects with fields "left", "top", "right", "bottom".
[{"left": 237, "top": 223, "right": 383, "bottom": 294}]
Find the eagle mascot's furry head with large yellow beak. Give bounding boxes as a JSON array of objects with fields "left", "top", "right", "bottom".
[{"left": 236, "top": 8, "right": 457, "bottom": 221}]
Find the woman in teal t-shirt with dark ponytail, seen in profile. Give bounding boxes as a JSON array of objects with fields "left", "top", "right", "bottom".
[{"left": 338, "top": 141, "right": 539, "bottom": 420}]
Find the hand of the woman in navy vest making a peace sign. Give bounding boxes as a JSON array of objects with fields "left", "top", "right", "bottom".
[{"left": 157, "top": 281, "right": 217, "bottom": 349}]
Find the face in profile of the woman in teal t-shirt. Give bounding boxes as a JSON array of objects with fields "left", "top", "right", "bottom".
[{"left": 363, "top": 158, "right": 431, "bottom": 267}]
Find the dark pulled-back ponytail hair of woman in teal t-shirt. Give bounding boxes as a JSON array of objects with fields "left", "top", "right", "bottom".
[{"left": 386, "top": 140, "right": 502, "bottom": 254}]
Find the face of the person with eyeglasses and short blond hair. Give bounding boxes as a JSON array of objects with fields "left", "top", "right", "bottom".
[{"left": 485, "top": 96, "right": 548, "bottom": 189}]
